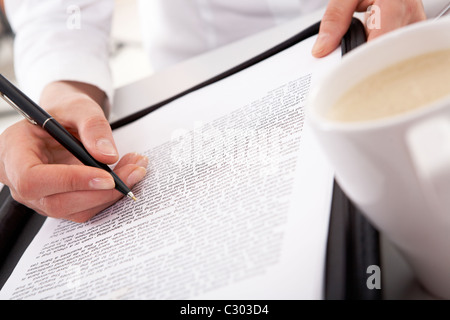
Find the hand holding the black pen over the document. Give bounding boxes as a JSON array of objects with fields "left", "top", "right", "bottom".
[{"left": 0, "top": 82, "right": 148, "bottom": 222}]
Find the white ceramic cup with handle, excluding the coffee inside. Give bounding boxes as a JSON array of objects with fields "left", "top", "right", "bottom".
[{"left": 307, "top": 18, "right": 450, "bottom": 299}]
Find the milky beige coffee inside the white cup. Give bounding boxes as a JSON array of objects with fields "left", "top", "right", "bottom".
[{"left": 326, "top": 49, "right": 450, "bottom": 122}]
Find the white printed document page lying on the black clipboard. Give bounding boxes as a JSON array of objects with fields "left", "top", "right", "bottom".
[{"left": 0, "top": 38, "right": 341, "bottom": 299}]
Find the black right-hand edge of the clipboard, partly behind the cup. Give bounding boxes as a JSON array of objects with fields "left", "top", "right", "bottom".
[{"left": 325, "top": 19, "right": 382, "bottom": 300}]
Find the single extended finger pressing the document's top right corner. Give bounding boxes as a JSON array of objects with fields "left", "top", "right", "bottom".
[{"left": 312, "top": 0, "right": 359, "bottom": 58}]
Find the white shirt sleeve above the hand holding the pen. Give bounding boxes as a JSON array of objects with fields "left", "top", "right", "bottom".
[{"left": 5, "top": 0, "right": 114, "bottom": 102}]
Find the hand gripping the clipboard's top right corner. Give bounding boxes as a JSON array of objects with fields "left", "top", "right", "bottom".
[{"left": 312, "top": 0, "right": 426, "bottom": 58}]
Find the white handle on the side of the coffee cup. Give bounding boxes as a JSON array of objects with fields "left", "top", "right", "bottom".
[{"left": 406, "top": 117, "right": 450, "bottom": 214}]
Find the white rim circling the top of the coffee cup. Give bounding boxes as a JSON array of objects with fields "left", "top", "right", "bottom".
[{"left": 306, "top": 18, "right": 450, "bottom": 131}]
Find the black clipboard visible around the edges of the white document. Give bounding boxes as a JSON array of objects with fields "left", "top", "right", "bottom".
[{"left": 0, "top": 18, "right": 381, "bottom": 300}]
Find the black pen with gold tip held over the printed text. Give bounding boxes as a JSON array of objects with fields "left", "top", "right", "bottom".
[{"left": 0, "top": 74, "right": 136, "bottom": 201}]
